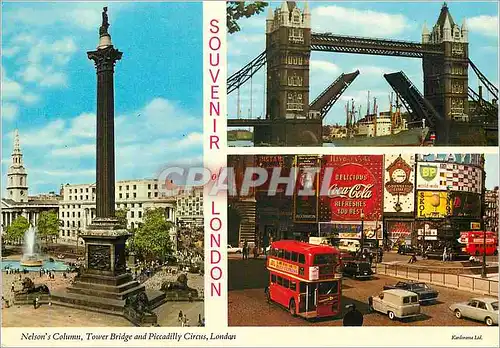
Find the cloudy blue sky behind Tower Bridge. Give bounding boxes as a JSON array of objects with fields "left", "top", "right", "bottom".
[{"left": 228, "top": 1, "right": 498, "bottom": 124}]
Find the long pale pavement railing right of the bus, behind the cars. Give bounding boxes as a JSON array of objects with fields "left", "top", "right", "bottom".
[{"left": 377, "top": 264, "right": 498, "bottom": 297}]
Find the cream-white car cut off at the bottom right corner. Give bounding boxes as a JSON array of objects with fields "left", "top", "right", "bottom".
[{"left": 450, "top": 297, "right": 498, "bottom": 326}]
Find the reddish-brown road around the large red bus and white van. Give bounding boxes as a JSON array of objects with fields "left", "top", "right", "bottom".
[{"left": 228, "top": 258, "right": 494, "bottom": 326}]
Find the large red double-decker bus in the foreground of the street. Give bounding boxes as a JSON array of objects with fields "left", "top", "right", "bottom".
[{"left": 266, "top": 240, "right": 342, "bottom": 319}]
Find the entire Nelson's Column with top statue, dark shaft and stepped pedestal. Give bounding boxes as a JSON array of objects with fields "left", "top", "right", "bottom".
[{"left": 52, "top": 7, "right": 165, "bottom": 325}]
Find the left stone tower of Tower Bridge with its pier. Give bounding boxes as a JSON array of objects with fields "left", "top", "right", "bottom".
[{"left": 260, "top": 1, "right": 322, "bottom": 146}]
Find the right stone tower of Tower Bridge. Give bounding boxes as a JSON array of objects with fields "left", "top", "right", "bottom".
[{"left": 422, "top": 2, "right": 469, "bottom": 121}]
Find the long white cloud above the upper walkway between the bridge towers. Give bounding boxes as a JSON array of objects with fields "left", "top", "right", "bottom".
[{"left": 312, "top": 5, "right": 412, "bottom": 37}]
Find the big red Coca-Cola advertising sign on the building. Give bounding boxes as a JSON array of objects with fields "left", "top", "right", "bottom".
[{"left": 320, "top": 155, "right": 383, "bottom": 222}]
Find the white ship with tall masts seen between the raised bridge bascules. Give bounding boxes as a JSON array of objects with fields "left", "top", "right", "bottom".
[{"left": 323, "top": 92, "right": 435, "bottom": 147}]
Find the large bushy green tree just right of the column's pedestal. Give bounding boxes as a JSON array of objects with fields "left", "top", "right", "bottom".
[{"left": 130, "top": 208, "right": 174, "bottom": 261}]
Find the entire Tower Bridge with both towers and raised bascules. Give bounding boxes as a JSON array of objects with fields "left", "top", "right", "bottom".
[{"left": 227, "top": 1, "right": 498, "bottom": 146}]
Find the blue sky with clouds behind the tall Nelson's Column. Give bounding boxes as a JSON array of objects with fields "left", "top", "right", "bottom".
[{"left": 2, "top": 3, "right": 203, "bottom": 194}]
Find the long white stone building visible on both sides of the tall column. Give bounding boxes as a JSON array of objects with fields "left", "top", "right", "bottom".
[{"left": 59, "top": 179, "right": 177, "bottom": 245}]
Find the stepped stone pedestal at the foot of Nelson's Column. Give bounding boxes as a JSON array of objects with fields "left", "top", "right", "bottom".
[{"left": 51, "top": 219, "right": 165, "bottom": 325}]
